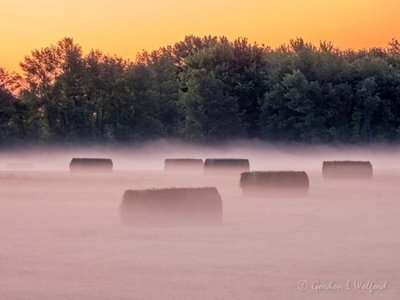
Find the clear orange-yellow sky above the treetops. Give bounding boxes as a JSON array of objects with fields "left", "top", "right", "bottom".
[{"left": 0, "top": 0, "right": 400, "bottom": 71}]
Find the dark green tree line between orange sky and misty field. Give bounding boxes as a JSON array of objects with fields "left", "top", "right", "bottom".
[{"left": 0, "top": 36, "right": 400, "bottom": 145}]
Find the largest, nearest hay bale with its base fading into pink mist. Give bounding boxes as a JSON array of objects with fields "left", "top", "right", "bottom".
[{"left": 120, "top": 187, "right": 222, "bottom": 226}]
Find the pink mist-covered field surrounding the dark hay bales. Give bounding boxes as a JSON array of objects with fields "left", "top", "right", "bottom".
[{"left": 0, "top": 144, "right": 400, "bottom": 300}]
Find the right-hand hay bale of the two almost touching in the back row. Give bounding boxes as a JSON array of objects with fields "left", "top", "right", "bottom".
[{"left": 204, "top": 158, "right": 250, "bottom": 174}]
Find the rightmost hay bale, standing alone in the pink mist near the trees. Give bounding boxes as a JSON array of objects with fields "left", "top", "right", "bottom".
[{"left": 322, "top": 161, "right": 373, "bottom": 179}]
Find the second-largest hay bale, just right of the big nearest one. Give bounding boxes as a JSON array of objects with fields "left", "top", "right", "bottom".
[{"left": 240, "top": 171, "right": 310, "bottom": 196}]
